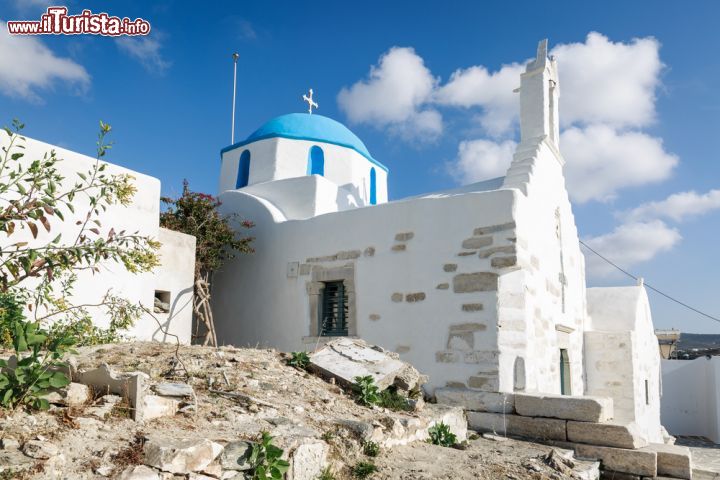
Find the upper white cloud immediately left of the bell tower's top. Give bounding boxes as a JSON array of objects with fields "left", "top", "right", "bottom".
[{"left": 435, "top": 63, "right": 525, "bottom": 136}]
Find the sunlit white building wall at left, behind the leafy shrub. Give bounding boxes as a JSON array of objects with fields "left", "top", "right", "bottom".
[{"left": 0, "top": 132, "right": 194, "bottom": 343}]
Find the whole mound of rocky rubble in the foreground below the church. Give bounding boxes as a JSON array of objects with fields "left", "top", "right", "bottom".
[{"left": 0, "top": 343, "right": 612, "bottom": 480}]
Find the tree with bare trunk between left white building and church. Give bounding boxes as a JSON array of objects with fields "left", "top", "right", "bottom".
[{"left": 160, "top": 180, "right": 253, "bottom": 346}]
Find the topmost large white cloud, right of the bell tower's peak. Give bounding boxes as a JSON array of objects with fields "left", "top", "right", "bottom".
[{"left": 551, "top": 32, "right": 663, "bottom": 127}]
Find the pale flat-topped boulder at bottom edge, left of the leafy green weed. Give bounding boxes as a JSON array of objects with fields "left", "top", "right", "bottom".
[{"left": 143, "top": 435, "right": 223, "bottom": 475}]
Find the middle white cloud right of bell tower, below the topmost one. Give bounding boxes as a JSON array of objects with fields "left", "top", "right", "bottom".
[{"left": 560, "top": 125, "right": 678, "bottom": 203}]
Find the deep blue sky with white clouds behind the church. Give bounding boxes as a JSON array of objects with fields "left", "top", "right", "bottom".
[{"left": 0, "top": 0, "right": 720, "bottom": 333}]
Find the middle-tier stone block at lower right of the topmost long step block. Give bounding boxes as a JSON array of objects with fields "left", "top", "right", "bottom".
[{"left": 564, "top": 420, "right": 649, "bottom": 449}]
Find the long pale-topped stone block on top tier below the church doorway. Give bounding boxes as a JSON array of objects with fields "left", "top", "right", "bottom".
[{"left": 515, "top": 393, "right": 613, "bottom": 423}]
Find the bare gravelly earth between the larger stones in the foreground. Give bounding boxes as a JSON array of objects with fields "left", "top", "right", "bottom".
[{"left": 0, "top": 342, "right": 588, "bottom": 480}]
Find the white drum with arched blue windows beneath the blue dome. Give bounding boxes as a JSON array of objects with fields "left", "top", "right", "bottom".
[{"left": 219, "top": 138, "right": 388, "bottom": 206}]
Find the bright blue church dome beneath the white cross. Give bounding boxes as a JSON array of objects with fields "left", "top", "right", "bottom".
[{"left": 223, "top": 113, "right": 387, "bottom": 171}]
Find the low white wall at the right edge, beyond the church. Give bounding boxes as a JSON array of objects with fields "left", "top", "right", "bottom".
[{"left": 661, "top": 357, "right": 720, "bottom": 443}]
